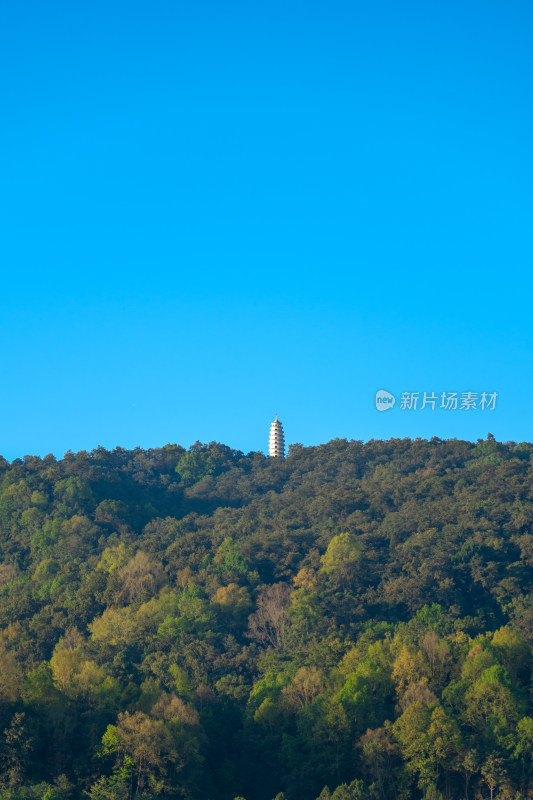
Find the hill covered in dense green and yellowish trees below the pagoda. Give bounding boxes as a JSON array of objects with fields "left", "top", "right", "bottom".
[{"left": 0, "top": 436, "right": 533, "bottom": 800}]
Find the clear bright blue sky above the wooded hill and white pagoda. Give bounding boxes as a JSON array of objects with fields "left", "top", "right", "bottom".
[{"left": 0, "top": 0, "right": 533, "bottom": 459}]
